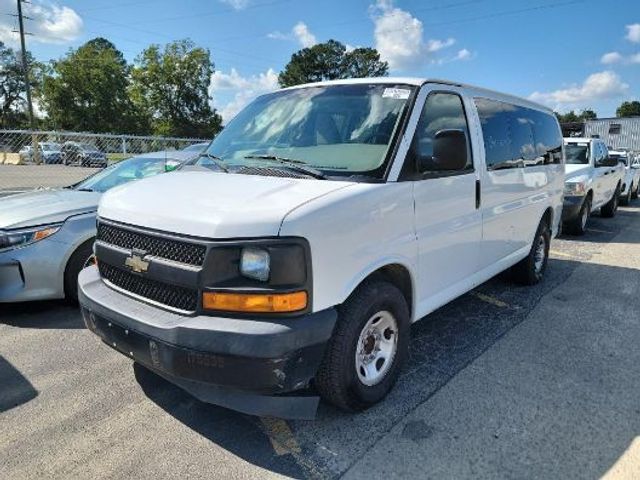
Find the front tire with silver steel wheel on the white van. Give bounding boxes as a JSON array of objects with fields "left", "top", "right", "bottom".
[{"left": 315, "top": 279, "right": 410, "bottom": 412}]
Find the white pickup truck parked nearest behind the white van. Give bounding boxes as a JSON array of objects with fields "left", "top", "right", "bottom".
[{"left": 562, "top": 138, "right": 625, "bottom": 235}]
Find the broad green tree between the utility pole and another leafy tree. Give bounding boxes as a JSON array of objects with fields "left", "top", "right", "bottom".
[{"left": 43, "top": 38, "right": 146, "bottom": 133}]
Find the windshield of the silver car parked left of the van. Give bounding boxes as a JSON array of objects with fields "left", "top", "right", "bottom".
[{"left": 74, "top": 157, "right": 165, "bottom": 192}]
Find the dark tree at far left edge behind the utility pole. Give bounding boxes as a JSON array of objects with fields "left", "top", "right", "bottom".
[{"left": 0, "top": 42, "right": 44, "bottom": 128}]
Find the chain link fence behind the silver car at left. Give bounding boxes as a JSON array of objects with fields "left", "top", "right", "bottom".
[{"left": 0, "top": 130, "right": 209, "bottom": 196}]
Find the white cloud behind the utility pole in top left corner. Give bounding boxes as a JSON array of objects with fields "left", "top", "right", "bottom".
[{"left": 0, "top": 0, "right": 83, "bottom": 44}]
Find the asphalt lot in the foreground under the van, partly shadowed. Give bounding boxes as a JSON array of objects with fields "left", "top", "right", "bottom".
[{"left": 0, "top": 202, "right": 640, "bottom": 479}]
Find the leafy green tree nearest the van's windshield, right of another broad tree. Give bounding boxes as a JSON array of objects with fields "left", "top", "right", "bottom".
[{"left": 131, "top": 40, "right": 222, "bottom": 138}]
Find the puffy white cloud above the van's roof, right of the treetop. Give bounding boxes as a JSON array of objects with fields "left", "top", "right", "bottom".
[{"left": 370, "top": 0, "right": 470, "bottom": 70}]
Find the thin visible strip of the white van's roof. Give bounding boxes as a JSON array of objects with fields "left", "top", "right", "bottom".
[{"left": 283, "top": 77, "right": 553, "bottom": 113}]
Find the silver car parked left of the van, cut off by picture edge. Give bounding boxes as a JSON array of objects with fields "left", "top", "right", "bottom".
[{"left": 0, "top": 152, "right": 192, "bottom": 303}]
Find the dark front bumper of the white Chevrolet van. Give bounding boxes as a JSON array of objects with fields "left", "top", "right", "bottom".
[{"left": 78, "top": 267, "right": 337, "bottom": 418}]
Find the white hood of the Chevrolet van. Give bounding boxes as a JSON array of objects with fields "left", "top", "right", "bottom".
[{"left": 98, "top": 170, "right": 353, "bottom": 239}]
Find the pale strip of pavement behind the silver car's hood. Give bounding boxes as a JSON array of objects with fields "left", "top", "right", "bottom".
[{"left": 0, "top": 165, "right": 99, "bottom": 196}]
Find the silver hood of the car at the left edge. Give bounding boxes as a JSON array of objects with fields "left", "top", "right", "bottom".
[{"left": 0, "top": 189, "right": 101, "bottom": 228}]
